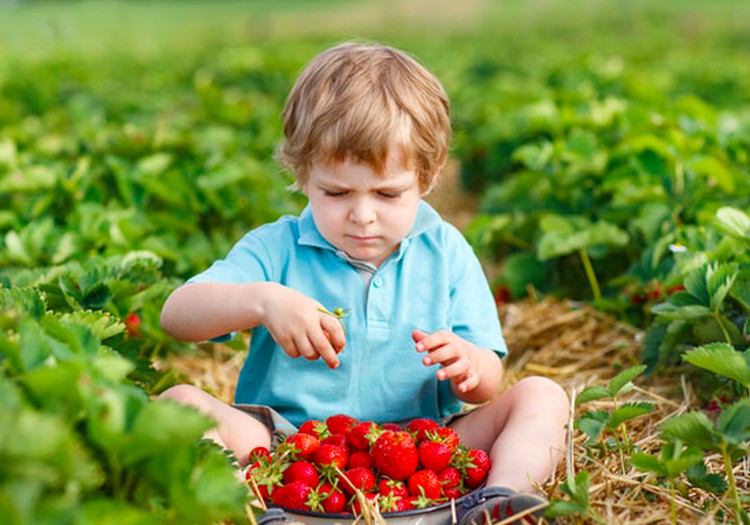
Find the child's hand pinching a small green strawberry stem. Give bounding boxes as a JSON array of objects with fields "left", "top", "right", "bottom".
[{"left": 263, "top": 286, "right": 346, "bottom": 368}]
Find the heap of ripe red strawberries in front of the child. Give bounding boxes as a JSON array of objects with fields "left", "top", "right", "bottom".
[{"left": 246, "top": 414, "right": 490, "bottom": 514}]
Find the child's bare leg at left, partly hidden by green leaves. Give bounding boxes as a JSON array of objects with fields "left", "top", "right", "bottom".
[{"left": 159, "top": 385, "right": 271, "bottom": 466}]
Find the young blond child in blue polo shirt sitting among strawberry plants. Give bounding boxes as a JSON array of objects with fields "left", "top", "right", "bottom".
[{"left": 161, "top": 43, "right": 569, "bottom": 524}]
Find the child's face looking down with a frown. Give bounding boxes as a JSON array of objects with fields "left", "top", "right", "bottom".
[{"left": 302, "top": 150, "right": 422, "bottom": 266}]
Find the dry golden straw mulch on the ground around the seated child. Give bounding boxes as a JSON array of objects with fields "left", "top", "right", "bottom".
[{"left": 167, "top": 298, "right": 750, "bottom": 525}]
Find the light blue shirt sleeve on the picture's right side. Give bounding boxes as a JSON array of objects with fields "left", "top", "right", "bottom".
[{"left": 449, "top": 230, "right": 508, "bottom": 358}]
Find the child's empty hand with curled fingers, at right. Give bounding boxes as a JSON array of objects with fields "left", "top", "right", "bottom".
[{"left": 411, "top": 330, "right": 479, "bottom": 394}]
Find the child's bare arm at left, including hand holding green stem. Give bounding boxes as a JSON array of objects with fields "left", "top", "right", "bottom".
[{"left": 161, "top": 282, "right": 346, "bottom": 368}]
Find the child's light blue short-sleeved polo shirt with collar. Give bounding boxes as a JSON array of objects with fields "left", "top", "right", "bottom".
[{"left": 190, "top": 202, "right": 507, "bottom": 425}]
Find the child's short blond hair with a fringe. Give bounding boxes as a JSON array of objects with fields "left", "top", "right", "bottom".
[{"left": 277, "top": 43, "right": 451, "bottom": 192}]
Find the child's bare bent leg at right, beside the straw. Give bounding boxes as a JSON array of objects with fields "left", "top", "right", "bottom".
[{"left": 451, "top": 377, "right": 570, "bottom": 492}]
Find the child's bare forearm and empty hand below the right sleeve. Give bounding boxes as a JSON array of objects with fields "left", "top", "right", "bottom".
[{"left": 412, "top": 330, "right": 503, "bottom": 404}]
